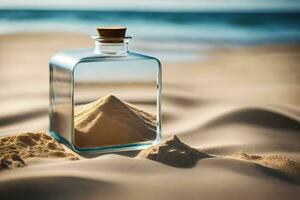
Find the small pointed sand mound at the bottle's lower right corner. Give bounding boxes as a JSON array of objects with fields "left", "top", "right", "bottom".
[{"left": 138, "top": 135, "right": 211, "bottom": 168}]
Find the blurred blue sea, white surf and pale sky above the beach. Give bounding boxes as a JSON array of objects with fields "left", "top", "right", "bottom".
[{"left": 0, "top": 0, "right": 300, "bottom": 60}]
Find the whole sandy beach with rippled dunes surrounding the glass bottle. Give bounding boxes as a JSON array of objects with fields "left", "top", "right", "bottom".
[{"left": 0, "top": 33, "right": 300, "bottom": 200}]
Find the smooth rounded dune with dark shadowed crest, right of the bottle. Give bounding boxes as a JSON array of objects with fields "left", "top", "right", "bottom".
[{"left": 171, "top": 106, "right": 300, "bottom": 155}]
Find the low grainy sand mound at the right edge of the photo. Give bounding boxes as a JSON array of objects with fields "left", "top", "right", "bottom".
[{"left": 233, "top": 152, "right": 300, "bottom": 183}]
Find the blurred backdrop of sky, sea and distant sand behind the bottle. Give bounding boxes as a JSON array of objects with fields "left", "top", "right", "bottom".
[{"left": 0, "top": 0, "right": 300, "bottom": 138}]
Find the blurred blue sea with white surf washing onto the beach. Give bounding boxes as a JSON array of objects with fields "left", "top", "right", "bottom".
[{"left": 0, "top": 9, "right": 300, "bottom": 61}]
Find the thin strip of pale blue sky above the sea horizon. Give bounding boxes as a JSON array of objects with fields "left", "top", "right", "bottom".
[{"left": 0, "top": 0, "right": 300, "bottom": 11}]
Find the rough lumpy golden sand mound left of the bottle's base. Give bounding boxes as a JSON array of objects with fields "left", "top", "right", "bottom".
[{"left": 0, "top": 133, "right": 78, "bottom": 171}]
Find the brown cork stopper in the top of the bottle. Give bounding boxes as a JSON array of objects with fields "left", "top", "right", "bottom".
[{"left": 97, "top": 27, "right": 126, "bottom": 39}]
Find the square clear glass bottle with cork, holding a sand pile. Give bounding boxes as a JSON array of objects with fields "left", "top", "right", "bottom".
[{"left": 50, "top": 27, "right": 162, "bottom": 152}]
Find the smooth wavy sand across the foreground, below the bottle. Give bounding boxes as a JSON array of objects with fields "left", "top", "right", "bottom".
[{"left": 0, "top": 138, "right": 299, "bottom": 200}]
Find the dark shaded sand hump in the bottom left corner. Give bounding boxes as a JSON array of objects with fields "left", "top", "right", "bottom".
[{"left": 0, "top": 175, "right": 117, "bottom": 199}]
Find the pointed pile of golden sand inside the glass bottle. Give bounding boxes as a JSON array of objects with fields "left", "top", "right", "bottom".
[{"left": 74, "top": 95, "right": 156, "bottom": 147}]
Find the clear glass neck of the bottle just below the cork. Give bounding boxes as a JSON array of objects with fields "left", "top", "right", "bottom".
[{"left": 94, "top": 40, "right": 128, "bottom": 56}]
